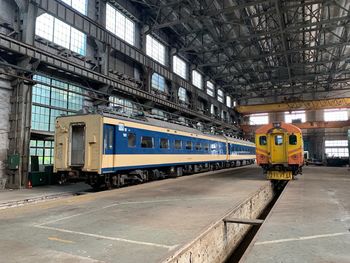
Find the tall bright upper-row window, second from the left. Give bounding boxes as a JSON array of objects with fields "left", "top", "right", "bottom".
[{"left": 106, "top": 3, "right": 135, "bottom": 45}]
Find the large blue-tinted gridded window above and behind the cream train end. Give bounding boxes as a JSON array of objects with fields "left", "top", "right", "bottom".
[{"left": 31, "top": 75, "right": 84, "bottom": 131}]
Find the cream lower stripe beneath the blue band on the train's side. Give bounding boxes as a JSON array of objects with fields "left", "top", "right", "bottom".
[{"left": 102, "top": 154, "right": 255, "bottom": 168}]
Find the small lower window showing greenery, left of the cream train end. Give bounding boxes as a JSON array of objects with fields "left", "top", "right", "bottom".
[{"left": 30, "top": 140, "right": 54, "bottom": 164}]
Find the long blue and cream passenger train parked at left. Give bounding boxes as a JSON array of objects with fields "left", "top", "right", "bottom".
[{"left": 54, "top": 114, "right": 255, "bottom": 188}]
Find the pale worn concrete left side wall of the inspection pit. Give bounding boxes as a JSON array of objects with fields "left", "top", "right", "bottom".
[{"left": 163, "top": 182, "right": 274, "bottom": 263}]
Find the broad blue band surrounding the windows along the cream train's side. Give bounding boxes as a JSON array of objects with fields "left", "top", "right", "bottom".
[{"left": 103, "top": 124, "right": 255, "bottom": 155}]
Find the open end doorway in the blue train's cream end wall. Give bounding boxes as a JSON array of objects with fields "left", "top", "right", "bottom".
[{"left": 70, "top": 123, "right": 85, "bottom": 166}]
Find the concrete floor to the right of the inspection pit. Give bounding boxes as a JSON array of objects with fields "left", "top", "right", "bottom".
[{"left": 240, "top": 167, "right": 350, "bottom": 263}]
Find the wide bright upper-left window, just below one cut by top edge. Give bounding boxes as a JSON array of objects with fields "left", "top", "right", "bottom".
[{"left": 35, "top": 13, "right": 86, "bottom": 56}]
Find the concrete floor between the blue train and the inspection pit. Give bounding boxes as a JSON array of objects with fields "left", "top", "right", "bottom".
[{"left": 0, "top": 166, "right": 269, "bottom": 263}]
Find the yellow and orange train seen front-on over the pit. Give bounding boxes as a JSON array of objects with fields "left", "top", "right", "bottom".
[{"left": 255, "top": 122, "right": 304, "bottom": 180}]
